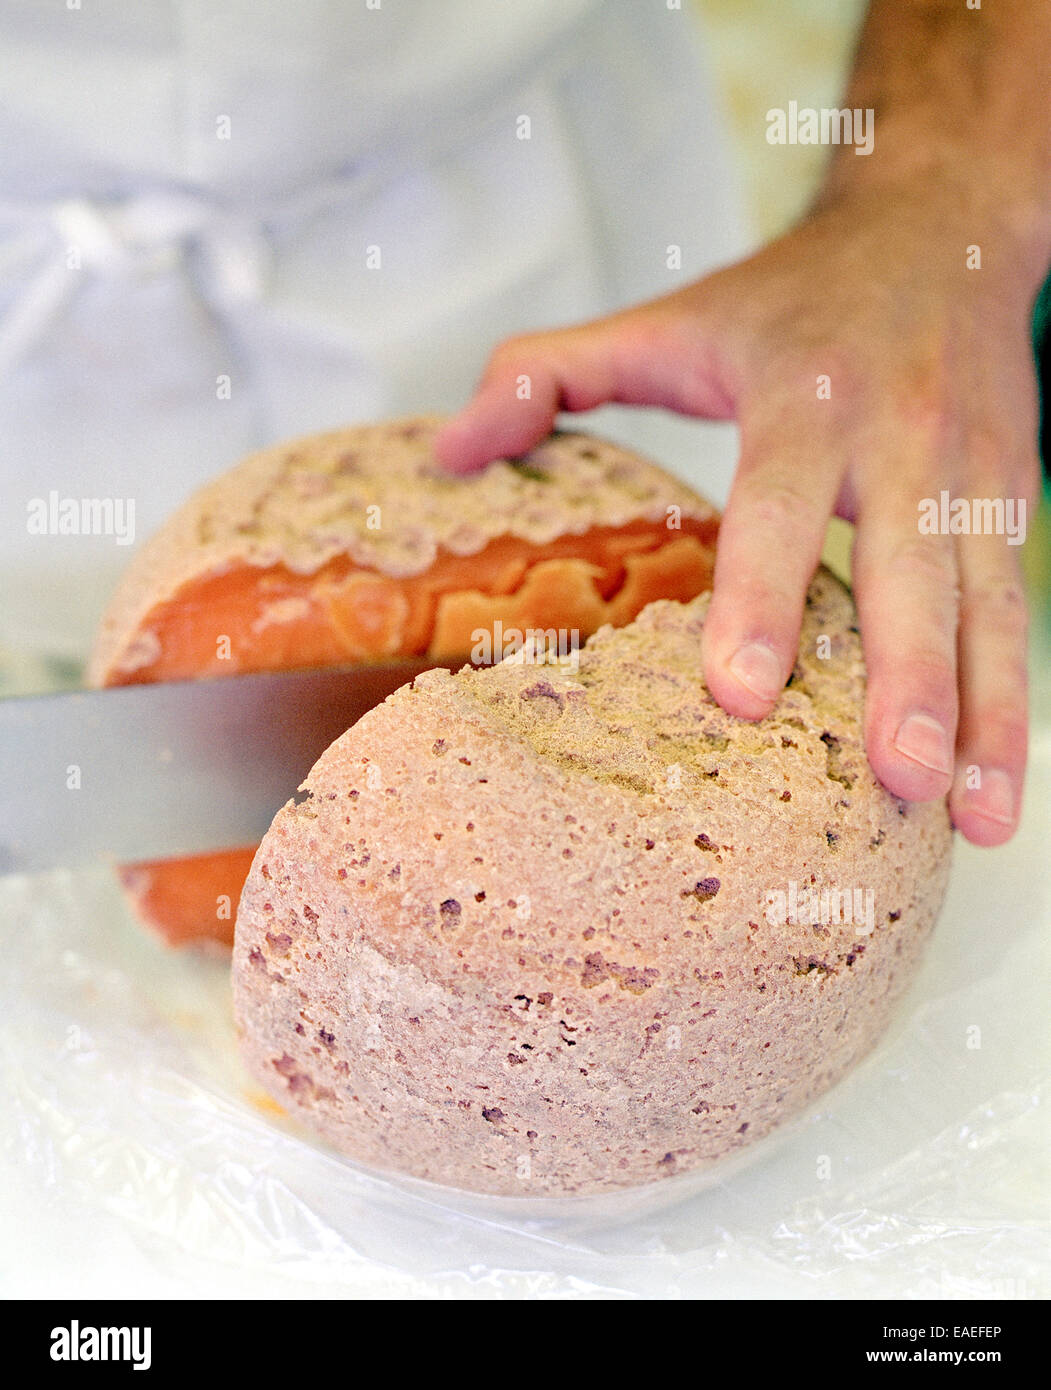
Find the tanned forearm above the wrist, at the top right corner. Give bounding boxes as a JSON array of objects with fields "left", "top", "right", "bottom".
[{"left": 816, "top": 0, "right": 1051, "bottom": 275}]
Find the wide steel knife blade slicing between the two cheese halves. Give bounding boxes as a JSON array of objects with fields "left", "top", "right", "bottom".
[{"left": 0, "top": 660, "right": 447, "bottom": 874}]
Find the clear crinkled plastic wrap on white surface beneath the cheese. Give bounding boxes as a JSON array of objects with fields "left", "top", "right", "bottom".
[{"left": 0, "top": 711, "right": 1051, "bottom": 1298}]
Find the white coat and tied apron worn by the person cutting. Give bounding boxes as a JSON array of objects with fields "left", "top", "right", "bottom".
[{"left": 0, "top": 0, "right": 745, "bottom": 656}]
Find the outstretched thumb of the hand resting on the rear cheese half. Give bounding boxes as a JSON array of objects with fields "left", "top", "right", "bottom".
[{"left": 434, "top": 297, "right": 734, "bottom": 473}]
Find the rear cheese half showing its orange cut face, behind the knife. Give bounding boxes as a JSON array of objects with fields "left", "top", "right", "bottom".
[{"left": 89, "top": 416, "right": 717, "bottom": 947}]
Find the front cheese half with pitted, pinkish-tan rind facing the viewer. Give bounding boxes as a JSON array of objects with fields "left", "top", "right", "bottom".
[{"left": 234, "top": 570, "right": 951, "bottom": 1197}]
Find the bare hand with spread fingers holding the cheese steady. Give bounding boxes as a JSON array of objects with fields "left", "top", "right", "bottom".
[{"left": 435, "top": 186, "right": 1038, "bottom": 845}]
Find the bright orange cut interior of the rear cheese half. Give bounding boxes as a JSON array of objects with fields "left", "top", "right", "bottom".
[{"left": 106, "top": 517, "right": 717, "bottom": 945}]
